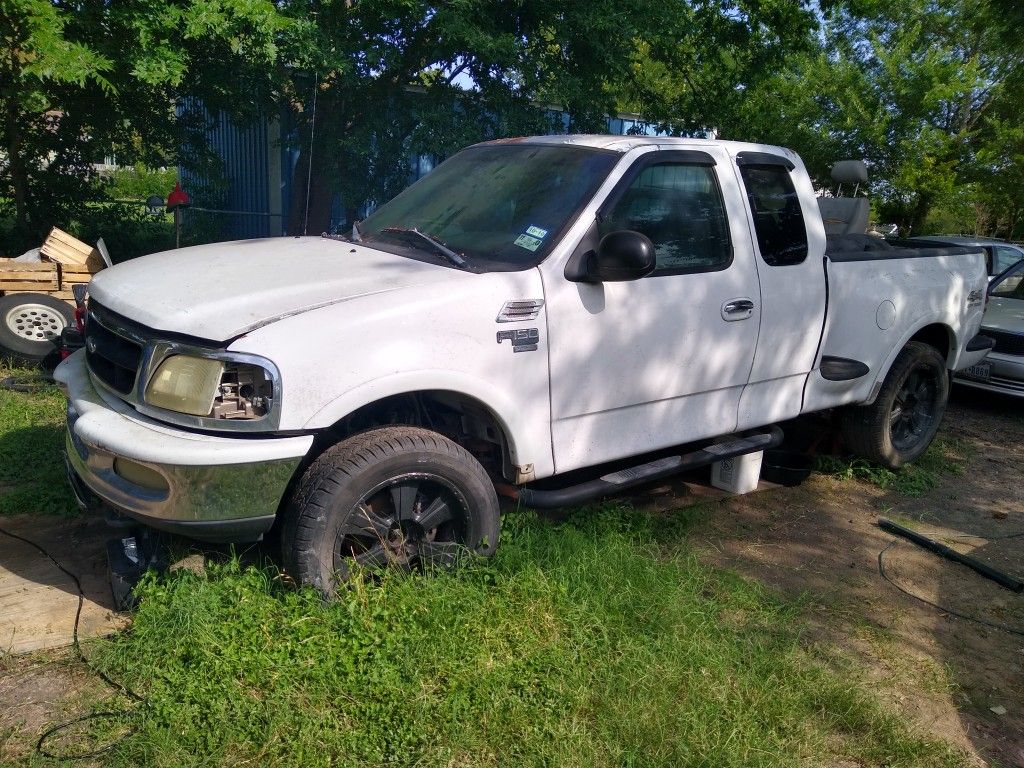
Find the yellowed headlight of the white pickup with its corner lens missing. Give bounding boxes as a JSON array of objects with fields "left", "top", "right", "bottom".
[{"left": 145, "top": 354, "right": 274, "bottom": 421}]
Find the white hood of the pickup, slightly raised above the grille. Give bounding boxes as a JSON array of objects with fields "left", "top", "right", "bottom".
[{"left": 89, "top": 238, "right": 473, "bottom": 342}]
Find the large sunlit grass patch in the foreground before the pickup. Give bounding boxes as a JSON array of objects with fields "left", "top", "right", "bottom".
[{"left": 68, "top": 508, "right": 962, "bottom": 768}]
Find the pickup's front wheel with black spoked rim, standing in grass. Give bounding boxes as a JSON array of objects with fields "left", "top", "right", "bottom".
[{"left": 282, "top": 427, "right": 499, "bottom": 596}]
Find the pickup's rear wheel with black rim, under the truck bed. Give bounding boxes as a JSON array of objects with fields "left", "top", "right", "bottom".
[{"left": 840, "top": 341, "right": 949, "bottom": 469}]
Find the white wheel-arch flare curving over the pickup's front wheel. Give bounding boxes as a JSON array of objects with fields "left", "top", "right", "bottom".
[{"left": 303, "top": 369, "right": 554, "bottom": 477}]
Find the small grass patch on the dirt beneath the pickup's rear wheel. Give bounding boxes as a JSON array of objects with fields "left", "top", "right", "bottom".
[{"left": 818, "top": 437, "right": 973, "bottom": 497}]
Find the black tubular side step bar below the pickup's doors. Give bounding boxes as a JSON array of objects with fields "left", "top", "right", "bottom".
[{"left": 502, "top": 427, "right": 783, "bottom": 509}]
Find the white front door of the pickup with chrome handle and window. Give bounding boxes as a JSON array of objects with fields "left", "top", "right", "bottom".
[{"left": 543, "top": 146, "right": 761, "bottom": 472}]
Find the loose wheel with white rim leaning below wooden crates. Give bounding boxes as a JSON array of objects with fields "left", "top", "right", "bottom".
[{"left": 0, "top": 293, "right": 75, "bottom": 362}]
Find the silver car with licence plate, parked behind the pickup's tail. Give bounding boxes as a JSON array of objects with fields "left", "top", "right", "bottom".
[{"left": 955, "top": 259, "right": 1024, "bottom": 397}]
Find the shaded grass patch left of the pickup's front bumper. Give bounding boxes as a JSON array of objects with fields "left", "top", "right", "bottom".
[{"left": 0, "top": 364, "right": 78, "bottom": 515}]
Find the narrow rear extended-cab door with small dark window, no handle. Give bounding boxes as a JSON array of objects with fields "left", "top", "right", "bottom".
[{"left": 735, "top": 152, "right": 827, "bottom": 429}]
